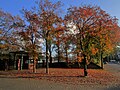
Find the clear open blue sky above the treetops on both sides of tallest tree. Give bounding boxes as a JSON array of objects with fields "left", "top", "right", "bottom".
[{"left": 0, "top": 0, "right": 120, "bottom": 25}]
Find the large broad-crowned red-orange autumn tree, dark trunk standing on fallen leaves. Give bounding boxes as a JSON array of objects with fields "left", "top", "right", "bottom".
[{"left": 65, "top": 5, "right": 117, "bottom": 76}]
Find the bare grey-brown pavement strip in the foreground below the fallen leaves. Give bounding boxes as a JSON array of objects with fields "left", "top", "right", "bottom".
[{"left": 0, "top": 78, "right": 120, "bottom": 90}]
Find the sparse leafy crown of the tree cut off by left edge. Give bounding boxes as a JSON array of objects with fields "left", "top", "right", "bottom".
[{"left": 0, "top": 10, "right": 22, "bottom": 52}]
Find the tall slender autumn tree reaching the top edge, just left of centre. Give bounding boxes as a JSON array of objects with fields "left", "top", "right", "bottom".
[{"left": 23, "top": 0, "right": 61, "bottom": 73}]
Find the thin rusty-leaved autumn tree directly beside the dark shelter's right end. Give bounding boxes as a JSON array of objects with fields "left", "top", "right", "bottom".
[{"left": 13, "top": 9, "right": 41, "bottom": 73}]
